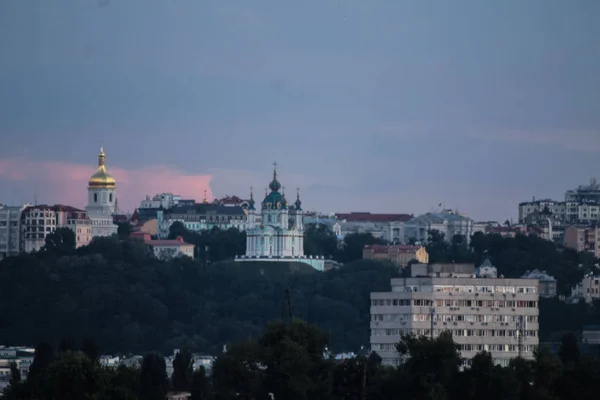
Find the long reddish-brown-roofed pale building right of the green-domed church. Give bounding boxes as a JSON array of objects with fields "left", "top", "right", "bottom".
[{"left": 335, "top": 212, "right": 413, "bottom": 243}]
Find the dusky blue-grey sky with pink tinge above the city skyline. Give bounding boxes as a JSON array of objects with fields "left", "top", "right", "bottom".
[{"left": 0, "top": 0, "right": 600, "bottom": 221}]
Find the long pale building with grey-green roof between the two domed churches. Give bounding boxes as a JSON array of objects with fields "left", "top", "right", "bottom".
[{"left": 157, "top": 203, "right": 248, "bottom": 238}]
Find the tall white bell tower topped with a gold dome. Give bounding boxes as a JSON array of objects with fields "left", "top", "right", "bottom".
[{"left": 85, "top": 147, "right": 118, "bottom": 237}]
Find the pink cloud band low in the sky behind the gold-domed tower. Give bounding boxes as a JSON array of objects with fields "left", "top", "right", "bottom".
[{"left": 0, "top": 158, "right": 213, "bottom": 211}]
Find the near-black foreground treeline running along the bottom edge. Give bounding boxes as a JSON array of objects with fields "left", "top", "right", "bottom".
[{"left": 5, "top": 319, "right": 600, "bottom": 400}]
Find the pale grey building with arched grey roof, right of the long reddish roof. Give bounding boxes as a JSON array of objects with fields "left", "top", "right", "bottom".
[{"left": 404, "top": 210, "right": 483, "bottom": 243}]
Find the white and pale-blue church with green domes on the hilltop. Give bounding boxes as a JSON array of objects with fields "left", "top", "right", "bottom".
[{"left": 236, "top": 164, "right": 325, "bottom": 271}]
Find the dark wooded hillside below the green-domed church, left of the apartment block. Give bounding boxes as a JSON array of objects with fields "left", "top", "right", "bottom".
[{"left": 0, "top": 228, "right": 397, "bottom": 353}]
